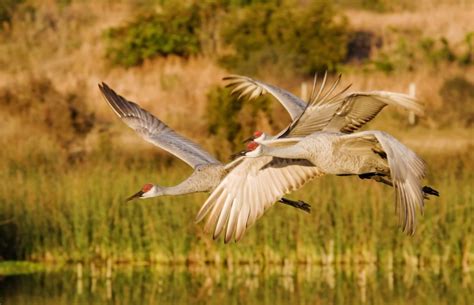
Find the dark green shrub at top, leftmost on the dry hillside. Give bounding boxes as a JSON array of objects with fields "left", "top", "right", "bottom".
[{"left": 106, "top": 5, "right": 200, "bottom": 67}]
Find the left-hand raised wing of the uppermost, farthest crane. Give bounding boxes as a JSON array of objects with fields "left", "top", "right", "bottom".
[{"left": 223, "top": 75, "right": 307, "bottom": 120}]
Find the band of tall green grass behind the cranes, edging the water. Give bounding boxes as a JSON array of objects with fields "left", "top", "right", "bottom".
[{"left": 0, "top": 141, "right": 474, "bottom": 265}]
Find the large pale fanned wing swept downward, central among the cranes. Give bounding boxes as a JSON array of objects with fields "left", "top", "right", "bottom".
[{"left": 196, "top": 156, "right": 321, "bottom": 242}]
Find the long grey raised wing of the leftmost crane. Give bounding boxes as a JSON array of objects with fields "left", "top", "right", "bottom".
[{"left": 99, "top": 83, "right": 220, "bottom": 168}]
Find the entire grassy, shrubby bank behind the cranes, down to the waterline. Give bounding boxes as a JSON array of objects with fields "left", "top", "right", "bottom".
[{"left": 0, "top": 0, "right": 474, "bottom": 276}]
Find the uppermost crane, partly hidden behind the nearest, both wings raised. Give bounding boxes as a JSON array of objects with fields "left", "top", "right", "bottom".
[{"left": 224, "top": 73, "right": 423, "bottom": 142}]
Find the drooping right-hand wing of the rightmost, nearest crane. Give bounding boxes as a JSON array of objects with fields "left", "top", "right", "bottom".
[{"left": 339, "top": 131, "right": 425, "bottom": 234}]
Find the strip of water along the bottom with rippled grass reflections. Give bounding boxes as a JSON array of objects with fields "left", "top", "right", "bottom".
[{"left": 0, "top": 266, "right": 474, "bottom": 305}]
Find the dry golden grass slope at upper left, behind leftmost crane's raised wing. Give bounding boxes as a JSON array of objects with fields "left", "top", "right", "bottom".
[{"left": 0, "top": 1, "right": 230, "bottom": 151}]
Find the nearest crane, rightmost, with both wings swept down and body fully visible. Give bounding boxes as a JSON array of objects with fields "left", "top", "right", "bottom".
[{"left": 198, "top": 131, "right": 439, "bottom": 241}]
